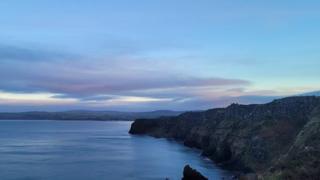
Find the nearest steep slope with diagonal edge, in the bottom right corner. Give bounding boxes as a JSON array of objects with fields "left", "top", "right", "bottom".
[{"left": 269, "top": 107, "right": 320, "bottom": 180}]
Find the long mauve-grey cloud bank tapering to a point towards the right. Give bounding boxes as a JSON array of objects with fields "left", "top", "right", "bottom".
[{"left": 0, "top": 44, "right": 250, "bottom": 96}]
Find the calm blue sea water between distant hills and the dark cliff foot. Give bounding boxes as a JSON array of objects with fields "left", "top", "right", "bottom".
[{"left": 0, "top": 121, "right": 229, "bottom": 180}]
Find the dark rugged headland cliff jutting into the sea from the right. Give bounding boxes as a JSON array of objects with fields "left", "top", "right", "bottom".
[{"left": 130, "top": 96, "right": 320, "bottom": 179}]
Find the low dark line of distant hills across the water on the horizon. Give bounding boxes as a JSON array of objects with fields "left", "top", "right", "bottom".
[{"left": 0, "top": 110, "right": 182, "bottom": 121}]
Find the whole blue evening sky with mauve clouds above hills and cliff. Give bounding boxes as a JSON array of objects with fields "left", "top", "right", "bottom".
[{"left": 0, "top": 0, "right": 320, "bottom": 112}]
